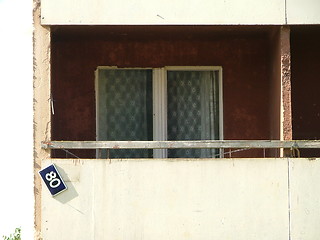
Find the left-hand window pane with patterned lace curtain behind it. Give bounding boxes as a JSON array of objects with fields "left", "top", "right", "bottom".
[{"left": 98, "top": 69, "right": 152, "bottom": 158}]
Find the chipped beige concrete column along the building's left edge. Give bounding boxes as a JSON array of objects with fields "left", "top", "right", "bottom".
[{"left": 33, "top": 0, "right": 51, "bottom": 240}]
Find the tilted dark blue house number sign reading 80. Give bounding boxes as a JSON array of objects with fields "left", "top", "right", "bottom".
[{"left": 39, "top": 164, "right": 67, "bottom": 196}]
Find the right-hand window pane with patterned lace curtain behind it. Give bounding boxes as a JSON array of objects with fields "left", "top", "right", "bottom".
[{"left": 167, "top": 71, "right": 219, "bottom": 158}]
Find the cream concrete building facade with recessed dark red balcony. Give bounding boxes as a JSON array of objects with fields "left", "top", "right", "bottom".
[{"left": 34, "top": 0, "right": 320, "bottom": 239}]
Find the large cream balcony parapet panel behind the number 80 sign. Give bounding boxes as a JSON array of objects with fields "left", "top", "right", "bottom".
[{"left": 42, "top": 159, "right": 289, "bottom": 240}]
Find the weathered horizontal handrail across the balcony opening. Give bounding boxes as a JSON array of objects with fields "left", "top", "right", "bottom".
[{"left": 41, "top": 140, "right": 320, "bottom": 149}]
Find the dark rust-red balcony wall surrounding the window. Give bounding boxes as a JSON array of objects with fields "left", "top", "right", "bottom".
[{"left": 52, "top": 27, "right": 270, "bottom": 157}]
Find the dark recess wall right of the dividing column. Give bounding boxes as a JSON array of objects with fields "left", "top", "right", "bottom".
[{"left": 291, "top": 26, "right": 320, "bottom": 157}]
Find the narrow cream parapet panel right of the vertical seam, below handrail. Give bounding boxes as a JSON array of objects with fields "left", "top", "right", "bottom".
[{"left": 290, "top": 159, "right": 320, "bottom": 240}]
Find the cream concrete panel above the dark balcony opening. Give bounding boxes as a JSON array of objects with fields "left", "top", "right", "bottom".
[{"left": 41, "top": 0, "right": 320, "bottom": 25}]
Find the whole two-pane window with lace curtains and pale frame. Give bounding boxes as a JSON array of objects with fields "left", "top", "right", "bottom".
[{"left": 96, "top": 67, "right": 222, "bottom": 158}]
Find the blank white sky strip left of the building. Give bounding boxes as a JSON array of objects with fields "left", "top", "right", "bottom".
[{"left": 0, "top": 0, "right": 34, "bottom": 240}]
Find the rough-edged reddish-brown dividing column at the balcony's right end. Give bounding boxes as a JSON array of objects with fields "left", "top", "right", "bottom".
[{"left": 269, "top": 26, "right": 292, "bottom": 157}]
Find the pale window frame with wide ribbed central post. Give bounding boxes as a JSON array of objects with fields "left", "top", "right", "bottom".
[{"left": 95, "top": 66, "right": 224, "bottom": 158}]
